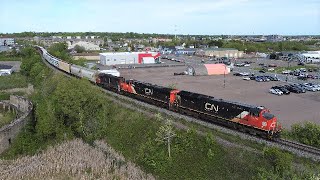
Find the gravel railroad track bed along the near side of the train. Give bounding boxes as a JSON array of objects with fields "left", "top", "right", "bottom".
[{"left": 37, "top": 50, "right": 320, "bottom": 161}]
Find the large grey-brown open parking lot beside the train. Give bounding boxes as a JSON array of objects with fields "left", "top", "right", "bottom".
[{"left": 120, "top": 57, "right": 320, "bottom": 128}]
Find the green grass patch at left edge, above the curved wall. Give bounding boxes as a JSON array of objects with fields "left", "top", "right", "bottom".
[{"left": 0, "top": 73, "right": 28, "bottom": 90}]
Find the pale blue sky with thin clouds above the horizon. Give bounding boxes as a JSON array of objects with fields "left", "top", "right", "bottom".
[{"left": 0, "top": 0, "right": 320, "bottom": 35}]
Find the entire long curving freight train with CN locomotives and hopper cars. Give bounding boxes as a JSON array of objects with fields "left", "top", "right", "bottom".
[{"left": 35, "top": 46, "right": 281, "bottom": 139}]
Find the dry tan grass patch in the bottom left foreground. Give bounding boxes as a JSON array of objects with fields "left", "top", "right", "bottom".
[{"left": 0, "top": 139, "right": 154, "bottom": 180}]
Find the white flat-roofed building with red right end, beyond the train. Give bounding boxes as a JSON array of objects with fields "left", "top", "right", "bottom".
[{"left": 100, "top": 52, "right": 160, "bottom": 66}]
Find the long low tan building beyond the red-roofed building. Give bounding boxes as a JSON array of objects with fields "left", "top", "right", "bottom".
[{"left": 195, "top": 48, "right": 243, "bottom": 58}]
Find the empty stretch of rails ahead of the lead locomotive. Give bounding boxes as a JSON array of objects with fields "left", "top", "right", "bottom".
[{"left": 275, "top": 138, "right": 320, "bottom": 157}]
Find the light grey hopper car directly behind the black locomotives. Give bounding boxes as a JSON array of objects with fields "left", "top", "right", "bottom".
[{"left": 70, "top": 64, "right": 97, "bottom": 82}]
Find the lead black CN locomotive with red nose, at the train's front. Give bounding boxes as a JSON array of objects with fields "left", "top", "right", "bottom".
[{"left": 170, "top": 91, "right": 279, "bottom": 137}]
